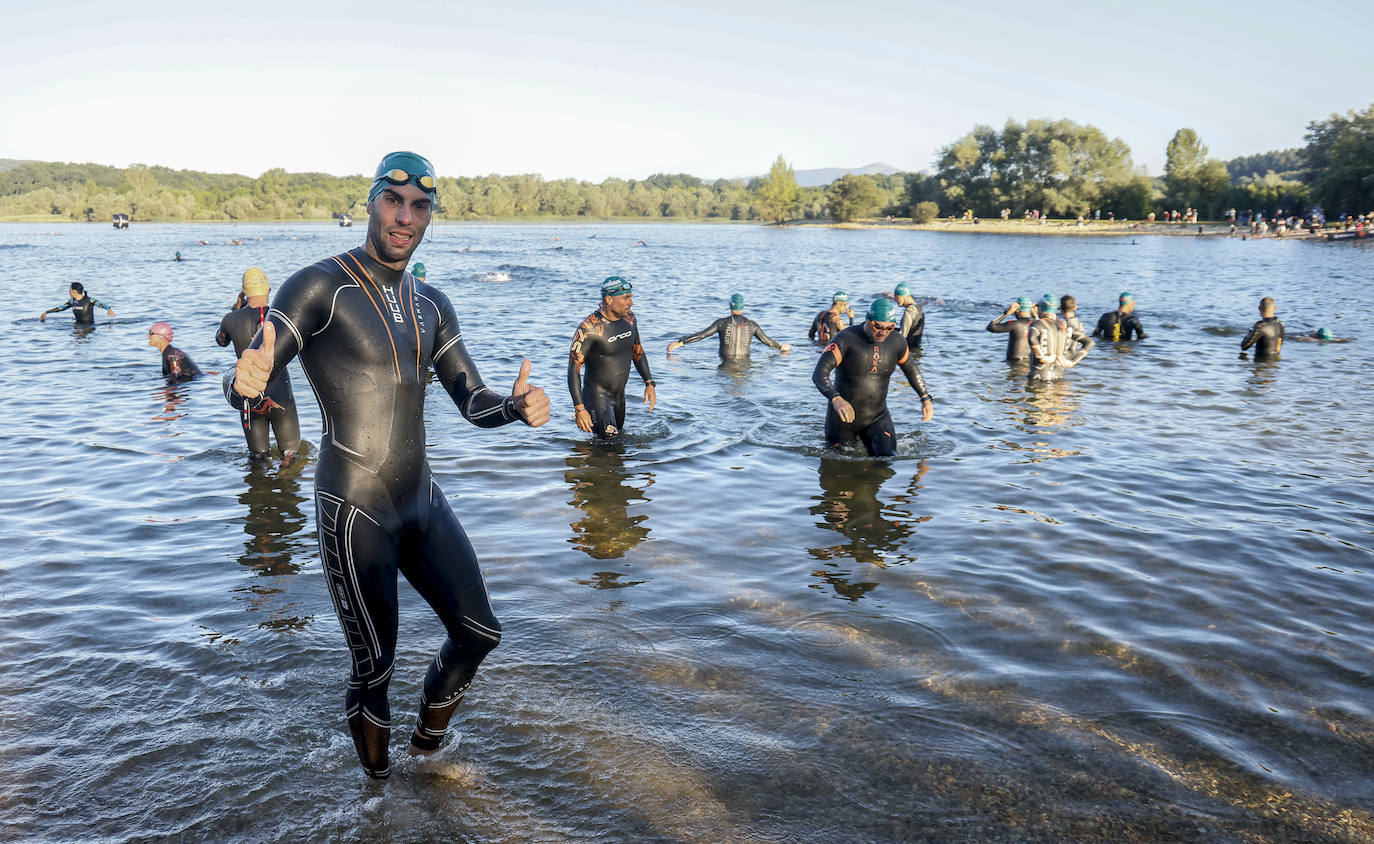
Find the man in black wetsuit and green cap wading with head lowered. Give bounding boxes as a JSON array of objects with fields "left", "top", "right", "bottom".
[{"left": 811, "top": 298, "right": 934, "bottom": 456}]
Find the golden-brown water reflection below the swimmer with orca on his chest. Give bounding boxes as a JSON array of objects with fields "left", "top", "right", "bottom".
[{"left": 563, "top": 440, "right": 654, "bottom": 571}]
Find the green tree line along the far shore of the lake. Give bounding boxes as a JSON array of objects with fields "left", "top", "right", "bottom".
[{"left": 8, "top": 104, "right": 1374, "bottom": 223}]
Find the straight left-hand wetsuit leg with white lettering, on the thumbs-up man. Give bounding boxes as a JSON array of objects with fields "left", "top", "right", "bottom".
[{"left": 315, "top": 489, "right": 398, "bottom": 779}]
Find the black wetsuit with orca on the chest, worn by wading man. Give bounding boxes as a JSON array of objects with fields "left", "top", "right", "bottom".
[{"left": 567, "top": 309, "right": 654, "bottom": 437}]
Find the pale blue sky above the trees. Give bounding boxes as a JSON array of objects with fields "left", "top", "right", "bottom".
[{"left": 0, "top": 0, "right": 1374, "bottom": 181}]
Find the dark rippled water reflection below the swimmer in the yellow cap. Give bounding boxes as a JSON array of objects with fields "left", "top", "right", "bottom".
[{"left": 234, "top": 459, "right": 315, "bottom": 630}]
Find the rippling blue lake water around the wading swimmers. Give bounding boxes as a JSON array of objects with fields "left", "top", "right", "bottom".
[{"left": 0, "top": 223, "right": 1374, "bottom": 841}]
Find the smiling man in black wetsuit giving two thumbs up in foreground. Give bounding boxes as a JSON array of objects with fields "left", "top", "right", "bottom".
[{"left": 225, "top": 153, "right": 548, "bottom": 779}]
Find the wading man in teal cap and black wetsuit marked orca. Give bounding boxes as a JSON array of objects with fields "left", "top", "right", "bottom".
[{"left": 567, "top": 275, "right": 658, "bottom": 438}]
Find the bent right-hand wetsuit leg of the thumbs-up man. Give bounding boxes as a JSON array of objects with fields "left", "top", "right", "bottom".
[{"left": 401, "top": 480, "right": 502, "bottom": 752}]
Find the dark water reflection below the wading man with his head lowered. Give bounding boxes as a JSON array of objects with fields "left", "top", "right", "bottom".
[{"left": 808, "top": 458, "right": 929, "bottom": 601}]
